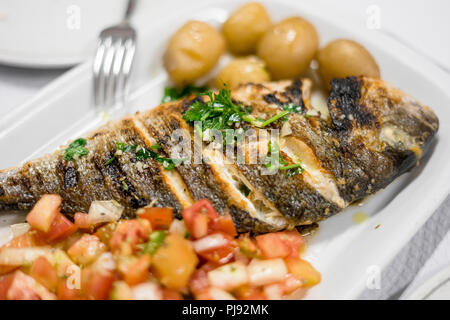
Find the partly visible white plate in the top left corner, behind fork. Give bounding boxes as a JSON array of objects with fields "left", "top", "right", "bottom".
[{"left": 0, "top": 0, "right": 126, "bottom": 68}]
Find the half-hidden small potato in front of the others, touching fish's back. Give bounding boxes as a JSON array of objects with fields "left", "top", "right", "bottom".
[{"left": 216, "top": 57, "right": 270, "bottom": 89}]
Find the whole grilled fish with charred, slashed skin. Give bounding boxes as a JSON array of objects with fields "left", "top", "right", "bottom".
[{"left": 0, "top": 77, "right": 439, "bottom": 233}]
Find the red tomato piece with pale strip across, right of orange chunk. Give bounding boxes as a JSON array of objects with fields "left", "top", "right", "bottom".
[{"left": 194, "top": 232, "right": 234, "bottom": 264}]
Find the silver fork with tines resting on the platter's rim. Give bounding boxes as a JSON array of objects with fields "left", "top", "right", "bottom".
[{"left": 92, "top": 0, "right": 136, "bottom": 108}]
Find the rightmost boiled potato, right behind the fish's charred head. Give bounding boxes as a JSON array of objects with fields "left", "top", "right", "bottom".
[{"left": 317, "top": 39, "right": 380, "bottom": 87}]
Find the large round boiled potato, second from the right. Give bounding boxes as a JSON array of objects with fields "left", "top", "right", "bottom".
[{"left": 258, "top": 17, "right": 319, "bottom": 79}]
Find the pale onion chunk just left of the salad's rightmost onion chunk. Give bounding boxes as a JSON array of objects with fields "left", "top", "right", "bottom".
[{"left": 208, "top": 262, "right": 248, "bottom": 290}]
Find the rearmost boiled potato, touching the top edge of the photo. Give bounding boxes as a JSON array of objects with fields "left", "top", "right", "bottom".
[{"left": 222, "top": 2, "right": 272, "bottom": 54}]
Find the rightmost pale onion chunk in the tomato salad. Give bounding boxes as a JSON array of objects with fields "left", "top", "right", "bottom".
[{"left": 247, "top": 259, "right": 287, "bottom": 286}]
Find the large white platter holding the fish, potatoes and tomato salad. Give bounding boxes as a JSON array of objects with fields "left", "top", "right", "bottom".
[{"left": 0, "top": 0, "right": 450, "bottom": 299}]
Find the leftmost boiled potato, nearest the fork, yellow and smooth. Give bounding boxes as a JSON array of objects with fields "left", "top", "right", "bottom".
[{"left": 164, "top": 21, "right": 225, "bottom": 86}]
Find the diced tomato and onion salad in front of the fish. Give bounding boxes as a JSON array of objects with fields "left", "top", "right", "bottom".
[{"left": 0, "top": 195, "right": 321, "bottom": 300}]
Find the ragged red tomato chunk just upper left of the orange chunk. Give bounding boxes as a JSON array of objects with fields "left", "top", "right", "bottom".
[{"left": 109, "top": 219, "right": 152, "bottom": 254}]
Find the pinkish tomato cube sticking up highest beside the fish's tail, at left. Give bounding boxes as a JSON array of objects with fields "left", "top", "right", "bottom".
[{"left": 27, "top": 194, "right": 62, "bottom": 232}]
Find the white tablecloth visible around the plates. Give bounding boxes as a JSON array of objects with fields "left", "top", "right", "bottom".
[{"left": 0, "top": 0, "right": 450, "bottom": 299}]
